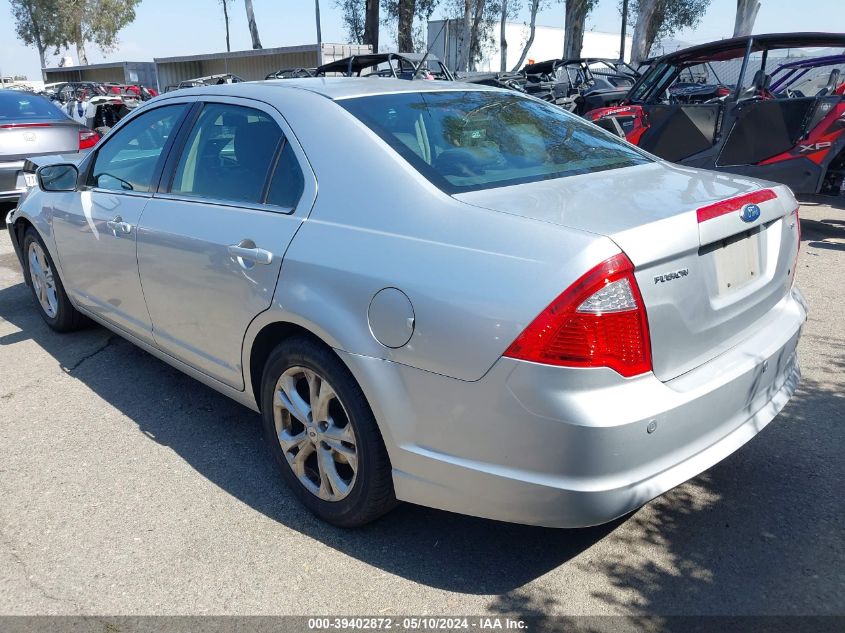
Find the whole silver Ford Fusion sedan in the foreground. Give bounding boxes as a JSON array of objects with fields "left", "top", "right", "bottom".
[{"left": 6, "top": 78, "right": 806, "bottom": 527}]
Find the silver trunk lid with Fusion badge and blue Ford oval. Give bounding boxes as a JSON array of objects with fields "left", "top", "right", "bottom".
[{"left": 456, "top": 163, "right": 798, "bottom": 381}]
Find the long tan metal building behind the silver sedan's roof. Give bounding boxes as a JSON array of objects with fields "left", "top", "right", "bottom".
[{"left": 155, "top": 44, "right": 372, "bottom": 91}]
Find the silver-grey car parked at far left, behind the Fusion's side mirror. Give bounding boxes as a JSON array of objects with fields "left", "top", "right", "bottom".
[{"left": 0, "top": 90, "right": 100, "bottom": 202}]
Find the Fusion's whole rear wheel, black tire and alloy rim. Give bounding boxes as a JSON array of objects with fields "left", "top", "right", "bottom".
[{"left": 261, "top": 337, "right": 396, "bottom": 527}]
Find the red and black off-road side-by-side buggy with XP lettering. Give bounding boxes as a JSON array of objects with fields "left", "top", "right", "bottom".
[{"left": 586, "top": 33, "right": 845, "bottom": 194}]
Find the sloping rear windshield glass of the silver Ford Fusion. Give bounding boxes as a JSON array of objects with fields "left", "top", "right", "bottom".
[{"left": 338, "top": 91, "right": 649, "bottom": 194}]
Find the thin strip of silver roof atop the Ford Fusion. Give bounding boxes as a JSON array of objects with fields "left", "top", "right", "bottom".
[{"left": 167, "top": 77, "right": 502, "bottom": 100}]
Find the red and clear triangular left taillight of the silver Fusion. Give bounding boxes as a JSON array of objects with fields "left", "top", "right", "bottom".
[{"left": 505, "top": 253, "right": 652, "bottom": 377}]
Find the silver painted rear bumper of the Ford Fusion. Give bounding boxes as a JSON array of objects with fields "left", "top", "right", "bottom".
[{"left": 342, "top": 290, "right": 806, "bottom": 527}]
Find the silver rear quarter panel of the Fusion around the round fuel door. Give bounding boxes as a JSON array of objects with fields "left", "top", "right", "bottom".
[{"left": 258, "top": 94, "right": 619, "bottom": 380}]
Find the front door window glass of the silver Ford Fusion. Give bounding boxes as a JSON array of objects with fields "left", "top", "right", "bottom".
[{"left": 88, "top": 103, "right": 186, "bottom": 192}]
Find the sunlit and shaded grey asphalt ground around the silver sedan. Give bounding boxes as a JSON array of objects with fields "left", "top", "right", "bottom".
[{"left": 0, "top": 202, "right": 845, "bottom": 616}]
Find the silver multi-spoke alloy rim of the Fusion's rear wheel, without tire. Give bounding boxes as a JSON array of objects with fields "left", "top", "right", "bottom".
[{"left": 273, "top": 367, "right": 358, "bottom": 501}]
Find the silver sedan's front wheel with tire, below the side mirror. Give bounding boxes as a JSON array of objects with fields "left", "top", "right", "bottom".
[{"left": 22, "top": 227, "right": 88, "bottom": 332}]
